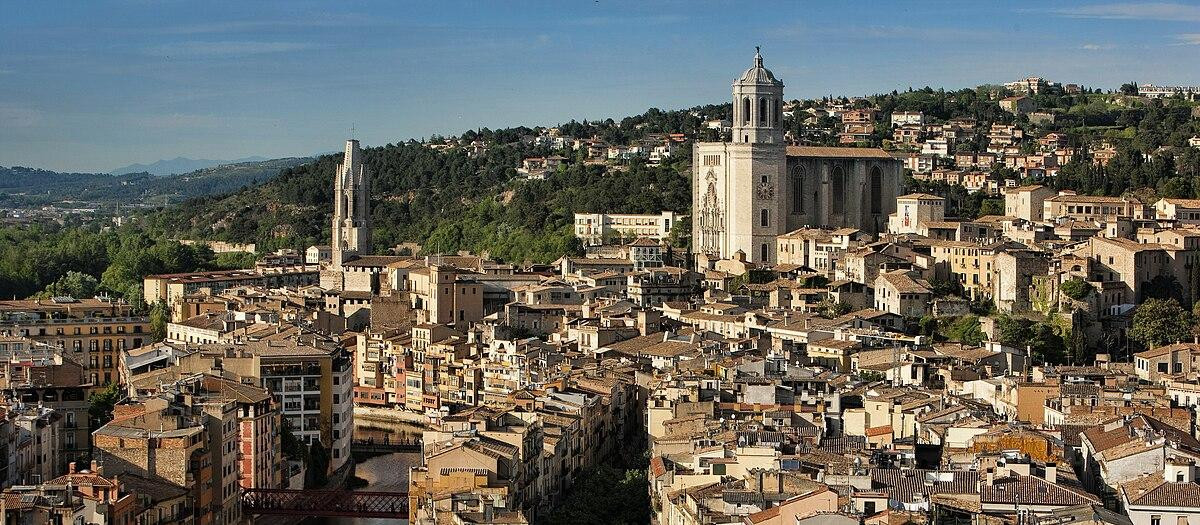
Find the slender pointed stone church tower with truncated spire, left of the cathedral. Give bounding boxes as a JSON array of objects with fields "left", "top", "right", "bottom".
[{"left": 330, "top": 139, "right": 371, "bottom": 266}]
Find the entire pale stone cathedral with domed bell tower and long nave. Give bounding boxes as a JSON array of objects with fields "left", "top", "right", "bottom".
[{"left": 691, "top": 53, "right": 902, "bottom": 263}]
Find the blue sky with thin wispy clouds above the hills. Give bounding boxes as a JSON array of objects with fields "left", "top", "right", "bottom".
[{"left": 0, "top": 0, "right": 1200, "bottom": 171}]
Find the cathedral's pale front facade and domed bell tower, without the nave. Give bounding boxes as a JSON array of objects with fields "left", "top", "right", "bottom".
[{"left": 692, "top": 47, "right": 787, "bottom": 263}]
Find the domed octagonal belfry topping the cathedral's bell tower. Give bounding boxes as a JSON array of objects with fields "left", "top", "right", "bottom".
[{"left": 733, "top": 47, "right": 784, "bottom": 144}]
